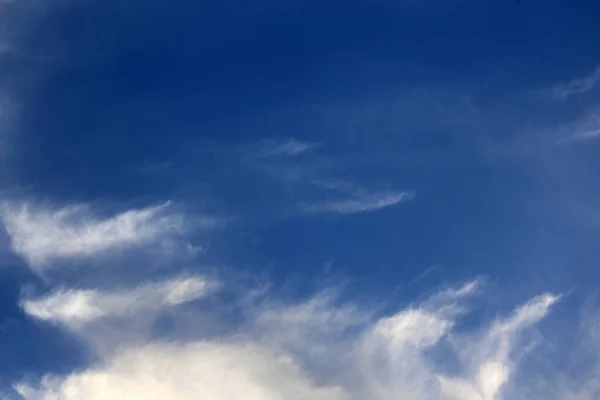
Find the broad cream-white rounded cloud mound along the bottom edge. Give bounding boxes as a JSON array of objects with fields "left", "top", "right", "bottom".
[{"left": 17, "top": 342, "right": 344, "bottom": 400}]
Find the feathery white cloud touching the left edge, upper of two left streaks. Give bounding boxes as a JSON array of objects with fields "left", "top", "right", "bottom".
[{"left": 0, "top": 203, "right": 184, "bottom": 267}]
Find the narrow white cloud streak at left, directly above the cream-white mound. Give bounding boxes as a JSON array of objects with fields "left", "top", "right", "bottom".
[{"left": 21, "top": 277, "right": 215, "bottom": 329}]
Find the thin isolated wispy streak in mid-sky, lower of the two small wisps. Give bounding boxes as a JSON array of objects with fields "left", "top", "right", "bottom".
[{"left": 305, "top": 191, "right": 414, "bottom": 214}]
